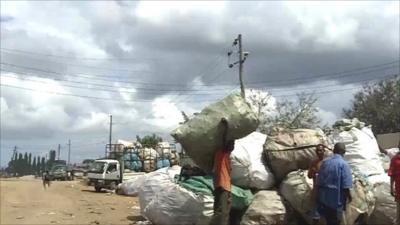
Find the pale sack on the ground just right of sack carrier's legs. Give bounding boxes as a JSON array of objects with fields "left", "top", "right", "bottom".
[{"left": 240, "top": 191, "right": 286, "bottom": 225}]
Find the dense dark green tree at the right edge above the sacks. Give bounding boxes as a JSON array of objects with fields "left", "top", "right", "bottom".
[{"left": 343, "top": 76, "right": 400, "bottom": 134}]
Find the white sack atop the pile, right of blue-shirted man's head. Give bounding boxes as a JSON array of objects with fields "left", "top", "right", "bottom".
[{"left": 332, "top": 120, "right": 385, "bottom": 176}]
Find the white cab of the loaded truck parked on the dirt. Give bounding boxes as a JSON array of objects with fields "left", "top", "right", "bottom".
[{"left": 87, "top": 159, "right": 122, "bottom": 192}]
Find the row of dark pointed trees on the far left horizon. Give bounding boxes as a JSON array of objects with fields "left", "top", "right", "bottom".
[{"left": 7, "top": 152, "right": 50, "bottom": 176}]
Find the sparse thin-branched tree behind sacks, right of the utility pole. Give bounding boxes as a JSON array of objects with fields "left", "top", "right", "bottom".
[{"left": 260, "top": 93, "right": 321, "bottom": 134}]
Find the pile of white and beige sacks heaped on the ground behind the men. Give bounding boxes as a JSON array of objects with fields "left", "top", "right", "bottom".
[{"left": 118, "top": 116, "right": 396, "bottom": 225}]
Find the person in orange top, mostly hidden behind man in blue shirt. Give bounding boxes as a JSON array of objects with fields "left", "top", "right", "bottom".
[{"left": 307, "top": 144, "right": 326, "bottom": 225}]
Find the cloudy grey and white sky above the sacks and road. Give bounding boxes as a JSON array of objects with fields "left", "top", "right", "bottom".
[{"left": 0, "top": 1, "right": 400, "bottom": 166}]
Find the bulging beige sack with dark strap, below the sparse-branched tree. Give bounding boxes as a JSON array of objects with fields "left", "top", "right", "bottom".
[{"left": 264, "top": 129, "right": 329, "bottom": 181}]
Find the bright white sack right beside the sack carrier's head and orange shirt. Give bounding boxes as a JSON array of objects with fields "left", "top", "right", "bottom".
[{"left": 231, "top": 132, "right": 275, "bottom": 190}]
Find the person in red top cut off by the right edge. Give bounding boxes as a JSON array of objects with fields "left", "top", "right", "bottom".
[{"left": 388, "top": 142, "right": 400, "bottom": 225}]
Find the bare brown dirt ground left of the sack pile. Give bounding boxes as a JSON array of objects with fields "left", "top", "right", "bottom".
[{"left": 0, "top": 178, "right": 144, "bottom": 224}]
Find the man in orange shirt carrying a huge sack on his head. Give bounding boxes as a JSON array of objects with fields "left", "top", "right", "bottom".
[{"left": 210, "top": 118, "right": 235, "bottom": 225}]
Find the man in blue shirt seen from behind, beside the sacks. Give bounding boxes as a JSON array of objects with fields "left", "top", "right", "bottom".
[{"left": 317, "top": 143, "right": 353, "bottom": 225}]
